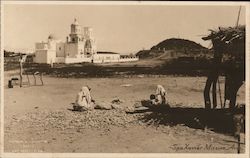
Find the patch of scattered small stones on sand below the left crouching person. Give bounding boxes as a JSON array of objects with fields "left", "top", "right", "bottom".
[{"left": 9, "top": 107, "right": 147, "bottom": 134}]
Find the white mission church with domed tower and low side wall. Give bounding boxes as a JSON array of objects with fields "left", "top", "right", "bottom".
[{"left": 34, "top": 19, "right": 138, "bottom": 64}]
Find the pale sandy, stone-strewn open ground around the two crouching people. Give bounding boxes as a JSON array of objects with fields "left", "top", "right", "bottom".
[{"left": 4, "top": 73, "right": 245, "bottom": 153}]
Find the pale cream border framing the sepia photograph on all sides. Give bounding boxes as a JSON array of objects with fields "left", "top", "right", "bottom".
[{"left": 0, "top": 1, "right": 250, "bottom": 158}]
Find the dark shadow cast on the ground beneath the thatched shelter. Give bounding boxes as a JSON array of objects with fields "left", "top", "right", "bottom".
[{"left": 129, "top": 101, "right": 245, "bottom": 134}]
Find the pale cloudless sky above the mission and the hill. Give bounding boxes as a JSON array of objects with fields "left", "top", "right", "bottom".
[{"left": 3, "top": 3, "right": 246, "bottom": 54}]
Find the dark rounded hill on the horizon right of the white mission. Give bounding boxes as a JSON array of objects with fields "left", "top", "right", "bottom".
[{"left": 136, "top": 38, "right": 209, "bottom": 58}]
